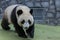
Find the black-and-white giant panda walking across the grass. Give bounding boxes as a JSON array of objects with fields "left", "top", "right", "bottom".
[{"left": 1, "top": 5, "right": 34, "bottom": 38}]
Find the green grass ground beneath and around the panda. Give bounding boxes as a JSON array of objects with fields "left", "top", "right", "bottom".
[{"left": 0, "top": 20, "right": 60, "bottom": 40}]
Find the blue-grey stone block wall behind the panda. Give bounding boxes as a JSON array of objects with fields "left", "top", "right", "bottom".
[{"left": 0, "top": 0, "right": 60, "bottom": 25}]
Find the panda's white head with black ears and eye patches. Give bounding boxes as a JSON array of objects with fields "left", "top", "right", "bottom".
[{"left": 16, "top": 6, "right": 34, "bottom": 29}]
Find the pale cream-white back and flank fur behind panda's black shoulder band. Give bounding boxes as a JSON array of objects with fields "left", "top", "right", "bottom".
[{"left": 5, "top": 5, "right": 18, "bottom": 23}]
